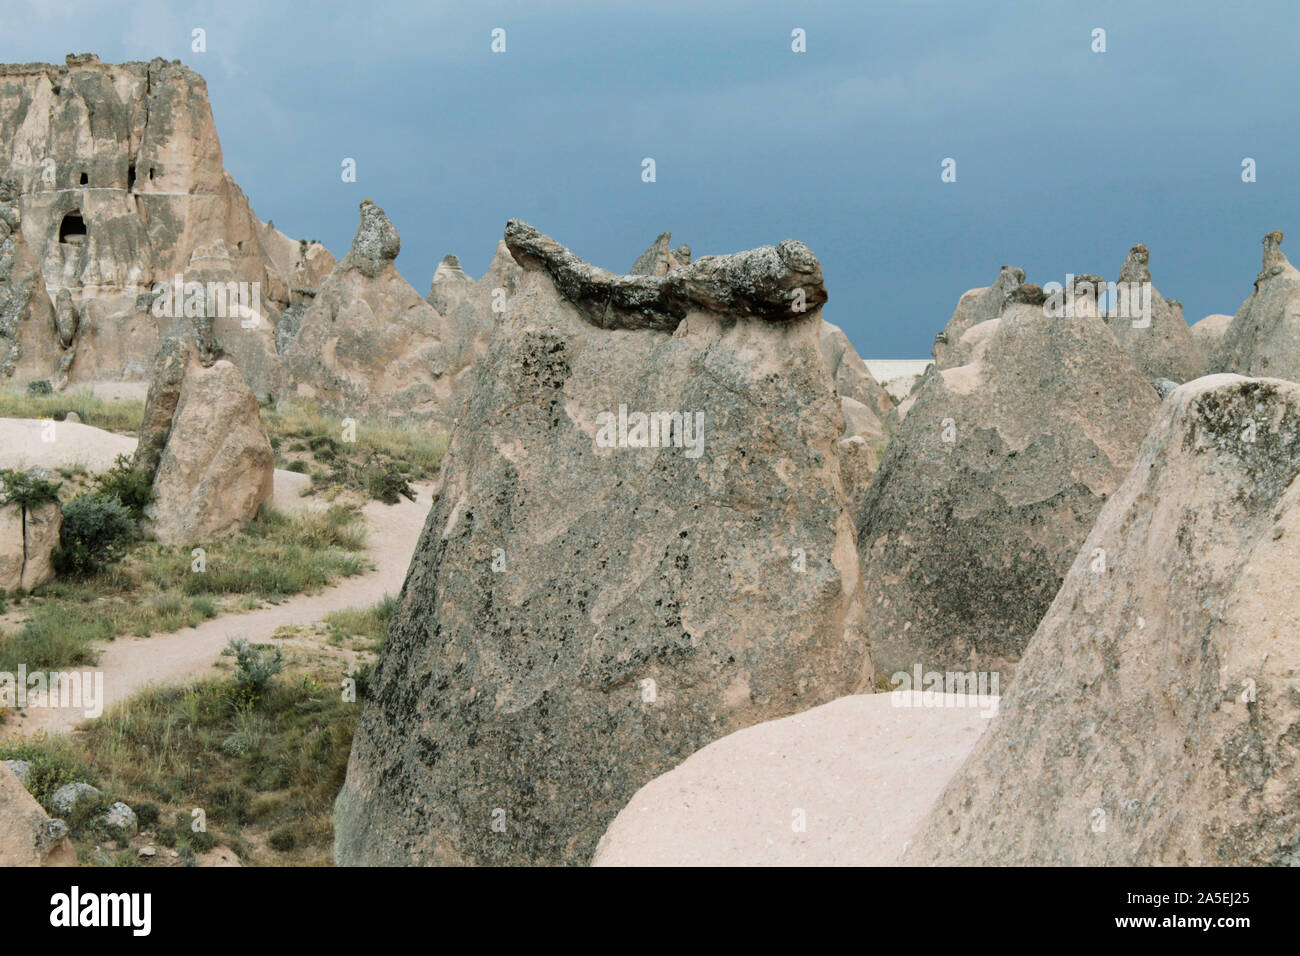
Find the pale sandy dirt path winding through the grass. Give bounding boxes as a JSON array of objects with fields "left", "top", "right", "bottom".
[{"left": 0, "top": 486, "right": 433, "bottom": 736}]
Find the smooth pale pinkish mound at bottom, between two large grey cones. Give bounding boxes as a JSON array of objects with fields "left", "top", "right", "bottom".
[{"left": 593, "top": 693, "right": 991, "bottom": 866}]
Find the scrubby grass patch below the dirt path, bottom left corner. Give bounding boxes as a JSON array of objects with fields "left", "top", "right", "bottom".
[{"left": 0, "top": 667, "right": 360, "bottom": 865}]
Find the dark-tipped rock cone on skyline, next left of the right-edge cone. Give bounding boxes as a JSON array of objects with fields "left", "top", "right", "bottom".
[{"left": 1106, "top": 243, "right": 1206, "bottom": 382}]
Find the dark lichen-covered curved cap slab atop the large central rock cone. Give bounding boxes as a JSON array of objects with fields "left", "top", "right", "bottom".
[{"left": 506, "top": 219, "right": 827, "bottom": 332}]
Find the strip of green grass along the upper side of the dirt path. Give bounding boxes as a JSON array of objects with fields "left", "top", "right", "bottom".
[{"left": 0, "top": 506, "right": 371, "bottom": 671}]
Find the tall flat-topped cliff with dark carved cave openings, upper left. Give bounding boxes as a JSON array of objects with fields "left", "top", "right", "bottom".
[{"left": 0, "top": 55, "right": 328, "bottom": 395}]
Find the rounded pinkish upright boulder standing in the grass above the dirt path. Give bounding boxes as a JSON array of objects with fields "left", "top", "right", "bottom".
[{"left": 137, "top": 349, "right": 276, "bottom": 545}]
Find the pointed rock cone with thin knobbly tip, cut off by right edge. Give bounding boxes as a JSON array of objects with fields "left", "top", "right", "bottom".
[{"left": 1213, "top": 232, "right": 1300, "bottom": 381}]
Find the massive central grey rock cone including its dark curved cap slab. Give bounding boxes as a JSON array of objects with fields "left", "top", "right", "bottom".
[{"left": 335, "top": 221, "right": 872, "bottom": 864}]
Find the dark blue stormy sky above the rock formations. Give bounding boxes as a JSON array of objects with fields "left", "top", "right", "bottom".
[{"left": 0, "top": 0, "right": 1300, "bottom": 358}]
